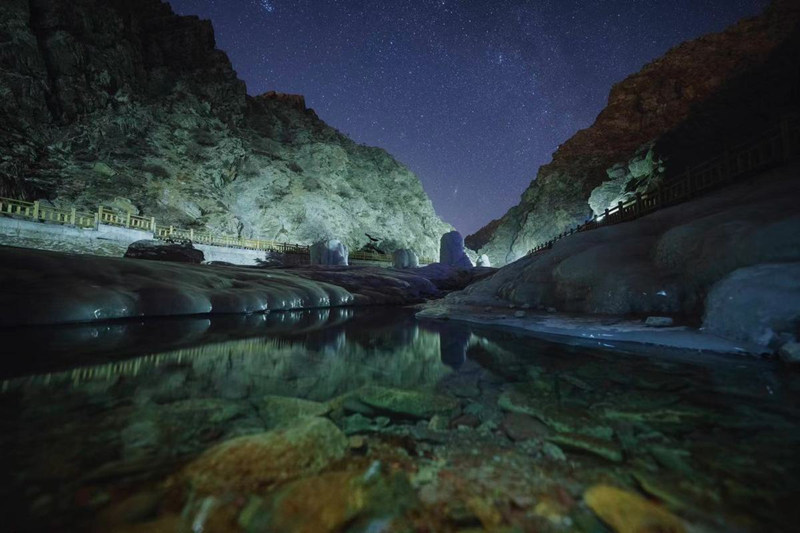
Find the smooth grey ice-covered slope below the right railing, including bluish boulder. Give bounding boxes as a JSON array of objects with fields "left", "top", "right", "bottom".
[{"left": 445, "top": 164, "right": 800, "bottom": 349}]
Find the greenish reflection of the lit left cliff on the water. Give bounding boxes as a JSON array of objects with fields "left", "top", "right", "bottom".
[{"left": 3, "top": 320, "right": 449, "bottom": 399}]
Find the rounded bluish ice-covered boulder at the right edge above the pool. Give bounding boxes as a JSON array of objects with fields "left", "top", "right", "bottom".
[{"left": 703, "top": 262, "right": 800, "bottom": 349}]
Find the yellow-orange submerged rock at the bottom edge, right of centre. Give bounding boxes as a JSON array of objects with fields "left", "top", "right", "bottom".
[{"left": 583, "top": 485, "right": 686, "bottom": 533}]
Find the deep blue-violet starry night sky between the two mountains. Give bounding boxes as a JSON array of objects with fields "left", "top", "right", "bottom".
[{"left": 170, "top": 0, "right": 769, "bottom": 235}]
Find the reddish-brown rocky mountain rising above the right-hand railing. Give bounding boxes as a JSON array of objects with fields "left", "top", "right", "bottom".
[{"left": 466, "top": 0, "right": 800, "bottom": 265}]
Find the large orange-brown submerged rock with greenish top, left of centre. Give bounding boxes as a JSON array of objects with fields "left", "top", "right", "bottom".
[{"left": 181, "top": 418, "right": 348, "bottom": 494}]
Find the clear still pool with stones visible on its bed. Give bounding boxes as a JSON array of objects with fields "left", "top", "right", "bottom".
[{"left": 0, "top": 308, "right": 800, "bottom": 532}]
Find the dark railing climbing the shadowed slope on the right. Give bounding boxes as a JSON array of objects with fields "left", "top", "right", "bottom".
[{"left": 528, "top": 117, "right": 800, "bottom": 255}]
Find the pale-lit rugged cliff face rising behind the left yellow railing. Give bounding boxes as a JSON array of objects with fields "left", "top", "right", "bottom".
[{"left": 0, "top": 0, "right": 451, "bottom": 257}]
